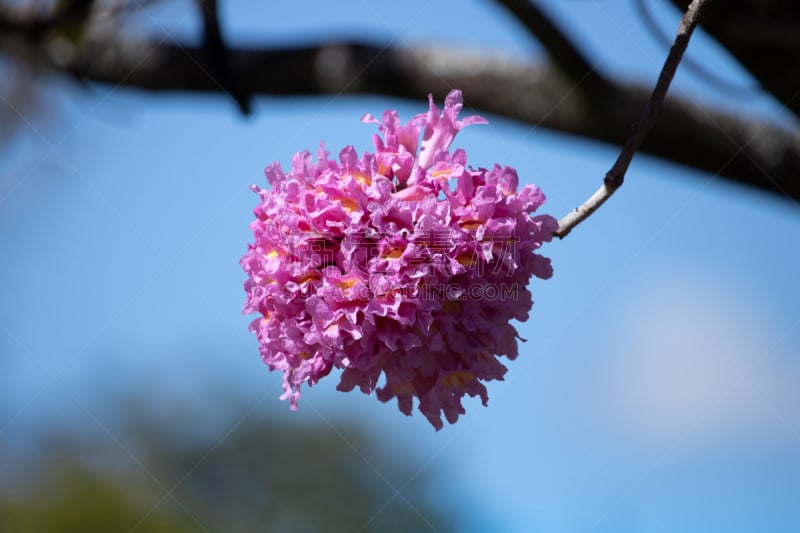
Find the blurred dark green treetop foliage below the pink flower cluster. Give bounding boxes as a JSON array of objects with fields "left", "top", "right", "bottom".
[{"left": 0, "top": 409, "right": 450, "bottom": 533}]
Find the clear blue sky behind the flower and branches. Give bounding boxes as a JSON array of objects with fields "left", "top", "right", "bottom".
[{"left": 0, "top": 0, "right": 800, "bottom": 532}]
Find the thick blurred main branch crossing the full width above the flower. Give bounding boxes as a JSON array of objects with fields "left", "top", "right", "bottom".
[{"left": 0, "top": 5, "right": 800, "bottom": 208}]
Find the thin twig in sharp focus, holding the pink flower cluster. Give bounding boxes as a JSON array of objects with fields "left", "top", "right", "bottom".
[{"left": 554, "top": 0, "right": 711, "bottom": 239}]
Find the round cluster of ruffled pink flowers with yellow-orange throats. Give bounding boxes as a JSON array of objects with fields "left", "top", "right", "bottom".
[{"left": 241, "top": 91, "right": 558, "bottom": 429}]
